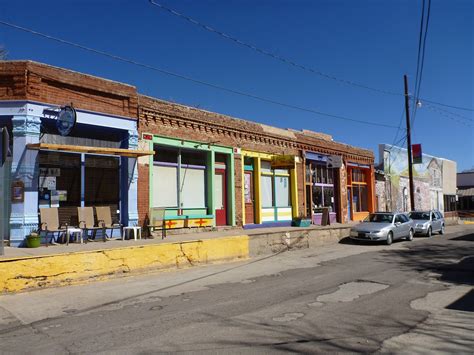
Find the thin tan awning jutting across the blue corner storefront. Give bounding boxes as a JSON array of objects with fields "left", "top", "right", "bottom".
[{"left": 27, "top": 143, "right": 155, "bottom": 158}]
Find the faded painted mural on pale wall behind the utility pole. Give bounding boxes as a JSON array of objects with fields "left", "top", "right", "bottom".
[{"left": 379, "top": 144, "right": 443, "bottom": 212}]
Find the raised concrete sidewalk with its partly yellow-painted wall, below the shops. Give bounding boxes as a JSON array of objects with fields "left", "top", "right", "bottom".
[{"left": 0, "top": 224, "right": 351, "bottom": 293}]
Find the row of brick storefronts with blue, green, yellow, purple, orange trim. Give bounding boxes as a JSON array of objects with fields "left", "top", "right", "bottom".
[{"left": 0, "top": 62, "right": 374, "bottom": 246}]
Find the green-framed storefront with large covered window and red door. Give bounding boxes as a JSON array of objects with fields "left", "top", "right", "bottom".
[{"left": 143, "top": 133, "right": 235, "bottom": 229}]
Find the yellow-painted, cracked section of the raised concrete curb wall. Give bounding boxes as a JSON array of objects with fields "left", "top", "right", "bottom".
[{"left": 0, "top": 235, "right": 249, "bottom": 293}]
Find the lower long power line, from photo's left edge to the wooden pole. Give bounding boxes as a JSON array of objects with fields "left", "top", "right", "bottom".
[{"left": 0, "top": 20, "right": 397, "bottom": 128}]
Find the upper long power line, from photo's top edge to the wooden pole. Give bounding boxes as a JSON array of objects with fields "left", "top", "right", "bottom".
[{"left": 149, "top": 0, "right": 403, "bottom": 96}]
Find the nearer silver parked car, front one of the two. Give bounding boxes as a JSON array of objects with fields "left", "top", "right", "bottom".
[{"left": 350, "top": 212, "right": 415, "bottom": 245}]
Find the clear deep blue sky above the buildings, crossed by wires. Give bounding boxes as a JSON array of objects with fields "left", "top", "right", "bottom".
[{"left": 0, "top": 0, "right": 474, "bottom": 171}]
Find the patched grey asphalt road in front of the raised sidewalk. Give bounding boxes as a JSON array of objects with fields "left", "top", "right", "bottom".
[{"left": 0, "top": 226, "right": 474, "bottom": 354}]
